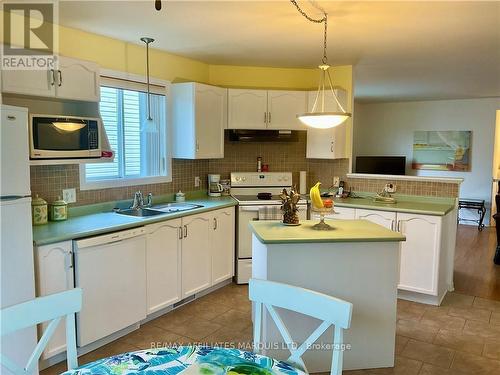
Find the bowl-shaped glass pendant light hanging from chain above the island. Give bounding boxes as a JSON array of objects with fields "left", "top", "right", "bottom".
[{"left": 290, "top": 0, "right": 352, "bottom": 129}]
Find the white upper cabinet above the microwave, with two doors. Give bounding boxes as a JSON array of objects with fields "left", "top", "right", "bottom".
[{"left": 2, "top": 56, "right": 100, "bottom": 102}]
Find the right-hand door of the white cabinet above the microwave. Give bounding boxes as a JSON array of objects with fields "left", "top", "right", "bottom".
[{"left": 56, "top": 57, "right": 100, "bottom": 102}]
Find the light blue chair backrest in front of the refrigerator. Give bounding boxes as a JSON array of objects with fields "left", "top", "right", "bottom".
[{"left": 0, "top": 288, "right": 82, "bottom": 374}]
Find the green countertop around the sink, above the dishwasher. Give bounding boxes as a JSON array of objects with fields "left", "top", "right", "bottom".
[{"left": 33, "top": 197, "right": 238, "bottom": 246}]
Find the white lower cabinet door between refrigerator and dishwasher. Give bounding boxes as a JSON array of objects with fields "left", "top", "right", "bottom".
[{"left": 35, "top": 241, "right": 75, "bottom": 359}]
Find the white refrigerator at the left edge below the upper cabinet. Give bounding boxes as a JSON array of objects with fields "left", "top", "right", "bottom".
[{"left": 0, "top": 105, "right": 37, "bottom": 374}]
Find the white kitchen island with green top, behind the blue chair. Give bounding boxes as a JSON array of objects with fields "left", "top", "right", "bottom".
[{"left": 250, "top": 220, "right": 405, "bottom": 372}]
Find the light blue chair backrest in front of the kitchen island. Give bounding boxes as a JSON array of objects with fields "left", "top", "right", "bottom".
[{"left": 249, "top": 279, "right": 352, "bottom": 375}]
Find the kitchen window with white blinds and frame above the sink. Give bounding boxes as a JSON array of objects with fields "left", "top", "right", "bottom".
[{"left": 80, "top": 74, "right": 171, "bottom": 190}]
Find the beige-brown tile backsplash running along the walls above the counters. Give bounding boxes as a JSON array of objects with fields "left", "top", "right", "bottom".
[{"left": 31, "top": 131, "right": 459, "bottom": 206}]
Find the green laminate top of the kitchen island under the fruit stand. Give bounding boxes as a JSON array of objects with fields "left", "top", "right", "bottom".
[{"left": 249, "top": 220, "right": 406, "bottom": 244}]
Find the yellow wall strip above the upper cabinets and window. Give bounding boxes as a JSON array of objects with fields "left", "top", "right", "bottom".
[{"left": 0, "top": 12, "right": 352, "bottom": 93}]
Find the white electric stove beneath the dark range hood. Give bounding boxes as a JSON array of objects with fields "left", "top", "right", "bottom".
[{"left": 231, "top": 172, "right": 307, "bottom": 284}]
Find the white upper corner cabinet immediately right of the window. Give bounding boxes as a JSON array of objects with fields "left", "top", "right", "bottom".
[{"left": 172, "top": 82, "right": 227, "bottom": 159}]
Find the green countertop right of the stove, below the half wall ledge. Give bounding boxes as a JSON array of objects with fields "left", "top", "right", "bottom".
[{"left": 308, "top": 193, "right": 457, "bottom": 216}]
